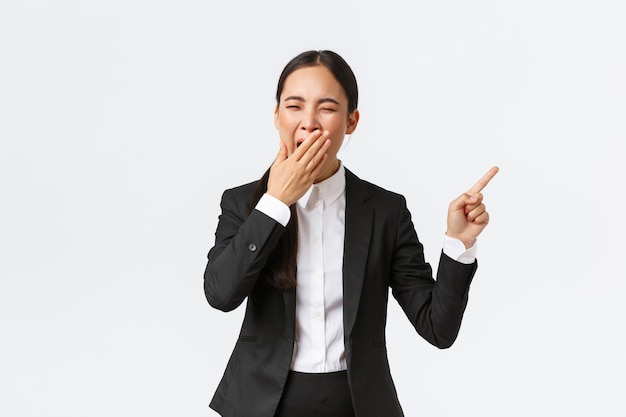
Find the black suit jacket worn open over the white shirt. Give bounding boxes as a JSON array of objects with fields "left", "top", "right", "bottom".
[{"left": 204, "top": 170, "right": 476, "bottom": 417}]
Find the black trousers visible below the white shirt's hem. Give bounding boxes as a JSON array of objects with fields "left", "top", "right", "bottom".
[{"left": 275, "top": 371, "right": 354, "bottom": 417}]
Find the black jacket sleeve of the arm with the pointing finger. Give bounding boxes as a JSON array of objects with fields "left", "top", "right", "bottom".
[{"left": 390, "top": 197, "right": 477, "bottom": 349}]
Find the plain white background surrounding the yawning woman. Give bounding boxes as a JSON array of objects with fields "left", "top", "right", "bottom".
[{"left": 0, "top": 0, "right": 626, "bottom": 417}]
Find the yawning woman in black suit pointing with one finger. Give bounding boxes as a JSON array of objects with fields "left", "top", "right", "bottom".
[{"left": 204, "top": 51, "right": 497, "bottom": 417}]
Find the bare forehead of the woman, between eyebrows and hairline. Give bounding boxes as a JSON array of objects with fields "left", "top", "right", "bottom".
[{"left": 281, "top": 65, "right": 346, "bottom": 102}]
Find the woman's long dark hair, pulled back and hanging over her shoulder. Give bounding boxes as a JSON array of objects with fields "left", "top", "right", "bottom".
[{"left": 248, "top": 51, "right": 359, "bottom": 290}]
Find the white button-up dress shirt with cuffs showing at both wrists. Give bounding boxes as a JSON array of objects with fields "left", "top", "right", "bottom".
[{"left": 256, "top": 164, "right": 476, "bottom": 373}]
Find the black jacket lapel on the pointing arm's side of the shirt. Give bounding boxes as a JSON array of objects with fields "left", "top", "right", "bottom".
[{"left": 343, "top": 169, "right": 374, "bottom": 340}]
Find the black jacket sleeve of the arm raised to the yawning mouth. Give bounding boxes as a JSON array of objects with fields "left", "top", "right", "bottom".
[{"left": 204, "top": 190, "right": 284, "bottom": 311}]
